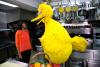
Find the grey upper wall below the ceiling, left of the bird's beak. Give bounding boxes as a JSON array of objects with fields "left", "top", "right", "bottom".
[{"left": 0, "top": 9, "right": 36, "bottom": 28}]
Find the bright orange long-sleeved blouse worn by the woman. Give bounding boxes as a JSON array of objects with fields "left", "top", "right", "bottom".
[{"left": 15, "top": 30, "right": 32, "bottom": 52}]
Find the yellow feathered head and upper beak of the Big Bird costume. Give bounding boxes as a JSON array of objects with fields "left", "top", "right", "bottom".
[{"left": 31, "top": 3, "right": 53, "bottom": 22}]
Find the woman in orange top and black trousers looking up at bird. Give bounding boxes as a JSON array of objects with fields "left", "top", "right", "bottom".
[{"left": 15, "top": 23, "right": 32, "bottom": 63}]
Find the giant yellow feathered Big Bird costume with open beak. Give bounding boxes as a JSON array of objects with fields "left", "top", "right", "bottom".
[{"left": 31, "top": 3, "right": 87, "bottom": 64}]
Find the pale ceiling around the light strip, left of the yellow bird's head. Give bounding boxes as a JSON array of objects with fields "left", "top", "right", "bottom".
[{"left": 0, "top": 0, "right": 42, "bottom": 11}]
